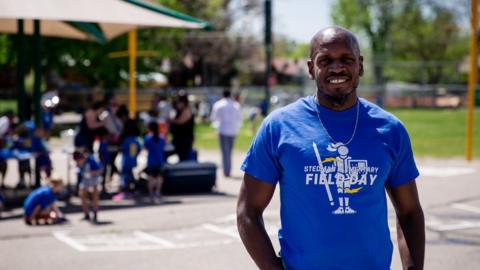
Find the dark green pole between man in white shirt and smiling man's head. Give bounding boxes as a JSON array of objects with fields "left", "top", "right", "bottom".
[{"left": 265, "top": 0, "right": 273, "bottom": 112}]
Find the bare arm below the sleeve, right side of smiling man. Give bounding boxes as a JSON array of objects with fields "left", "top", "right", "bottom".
[{"left": 389, "top": 181, "right": 425, "bottom": 270}]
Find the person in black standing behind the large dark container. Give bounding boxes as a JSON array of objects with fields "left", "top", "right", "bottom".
[{"left": 170, "top": 93, "right": 195, "bottom": 161}]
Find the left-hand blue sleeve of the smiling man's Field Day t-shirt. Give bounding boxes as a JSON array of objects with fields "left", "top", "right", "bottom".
[{"left": 241, "top": 118, "right": 282, "bottom": 184}]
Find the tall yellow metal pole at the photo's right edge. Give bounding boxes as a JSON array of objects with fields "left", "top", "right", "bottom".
[{"left": 466, "top": 0, "right": 478, "bottom": 161}]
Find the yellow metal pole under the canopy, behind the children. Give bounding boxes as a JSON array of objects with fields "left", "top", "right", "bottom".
[{"left": 128, "top": 30, "right": 137, "bottom": 119}]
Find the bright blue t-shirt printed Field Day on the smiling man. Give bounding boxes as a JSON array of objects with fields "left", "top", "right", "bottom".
[{"left": 242, "top": 96, "right": 418, "bottom": 270}]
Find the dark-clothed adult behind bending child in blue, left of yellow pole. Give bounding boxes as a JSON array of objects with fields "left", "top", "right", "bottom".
[{"left": 75, "top": 102, "right": 104, "bottom": 153}]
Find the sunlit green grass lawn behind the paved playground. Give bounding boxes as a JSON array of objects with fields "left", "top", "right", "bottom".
[{"left": 195, "top": 109, "right": 480, "bottom": 158}]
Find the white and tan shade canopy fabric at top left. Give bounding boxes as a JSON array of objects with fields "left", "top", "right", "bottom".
[{"left": 0, "top": 0, "right": 208, "bottom": 40}]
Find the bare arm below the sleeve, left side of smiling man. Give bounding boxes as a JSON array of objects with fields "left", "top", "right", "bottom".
[{"left": 237, "top": 174, "right": 283, "bottom": 270}]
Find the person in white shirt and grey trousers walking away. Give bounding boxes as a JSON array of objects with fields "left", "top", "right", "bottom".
[{"left": 210, "top": 89, "right": 242, "bottom": 177}]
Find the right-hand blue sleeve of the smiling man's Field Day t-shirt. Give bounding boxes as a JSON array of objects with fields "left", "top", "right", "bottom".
[{"left": 387, "top": 123, "right": 419, "bottom": 188}]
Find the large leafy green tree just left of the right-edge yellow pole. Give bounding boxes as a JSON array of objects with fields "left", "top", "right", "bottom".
[{"left": 387, "top": 0, "right": 468, "bottom": 84}]
